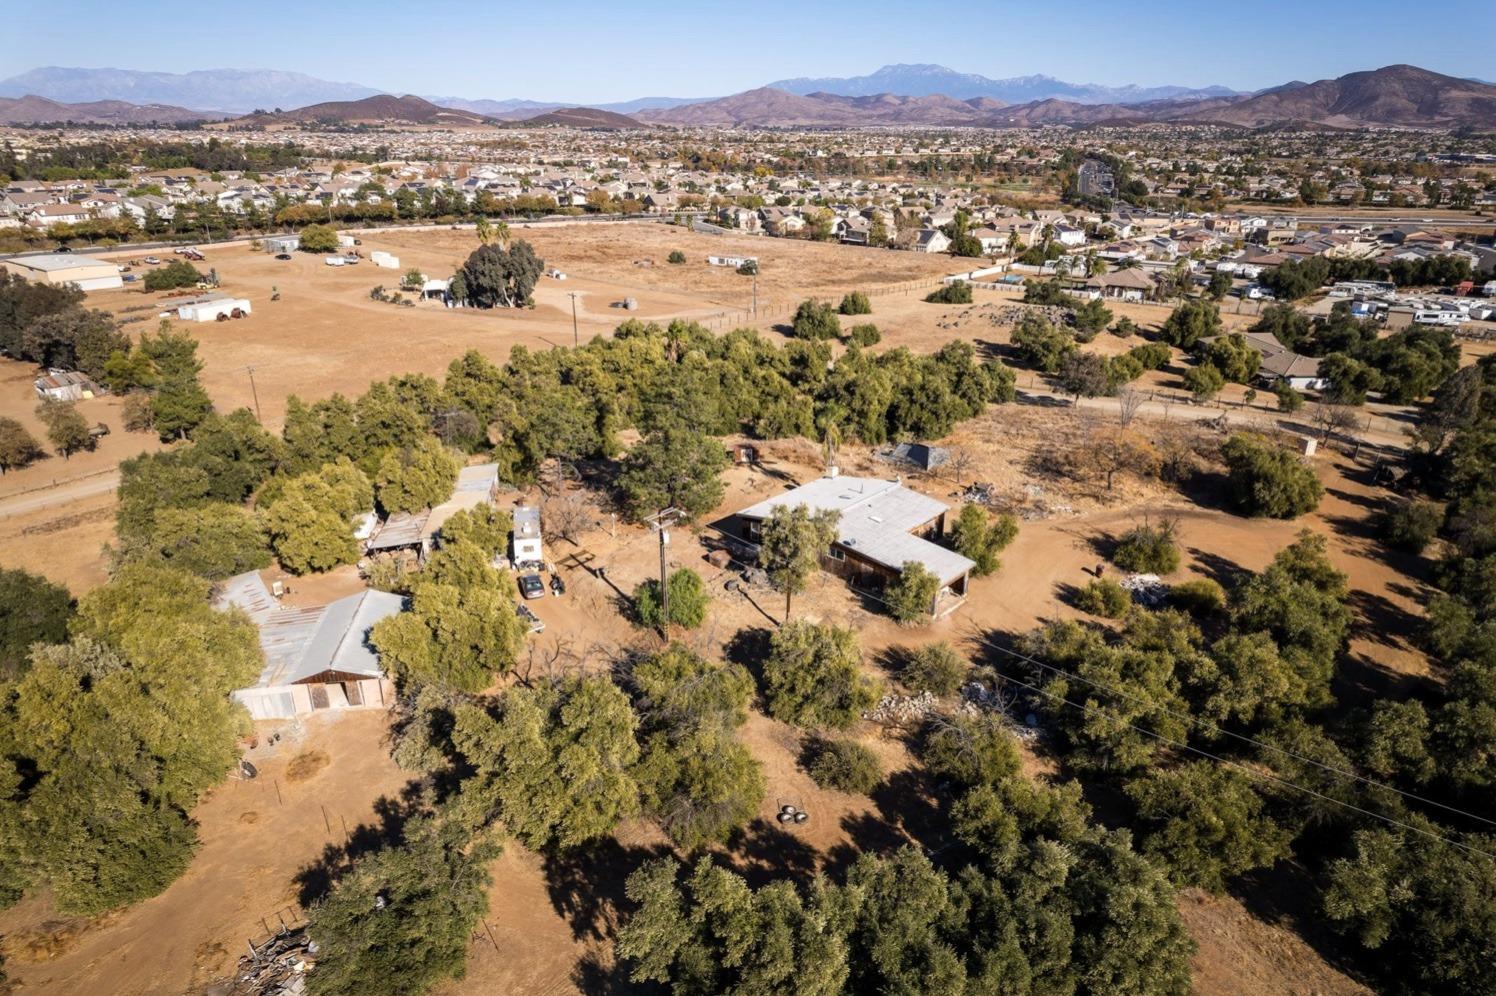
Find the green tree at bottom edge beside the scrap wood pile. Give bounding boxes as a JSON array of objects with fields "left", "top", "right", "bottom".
[{"left": 307, "top": 817, "right": 498, "bottom": 996}]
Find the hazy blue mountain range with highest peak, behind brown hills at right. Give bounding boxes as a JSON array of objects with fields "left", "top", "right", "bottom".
[{"left": 769, "top": 64, "right": 1237, "bottom": 103}]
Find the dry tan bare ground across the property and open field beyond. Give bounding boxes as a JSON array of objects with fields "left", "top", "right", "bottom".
[{"left": 0, "top": 226, "right": 1429, "bottom": 996}]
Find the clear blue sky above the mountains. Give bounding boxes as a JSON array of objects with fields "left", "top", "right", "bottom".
[{"left": 0, "top": 0, "right": 1496, "bottom": 103}]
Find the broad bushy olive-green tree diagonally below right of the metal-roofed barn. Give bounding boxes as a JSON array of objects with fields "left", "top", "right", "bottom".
[{"left": 452, "top": 677, "right": 639, "bottom": 851}]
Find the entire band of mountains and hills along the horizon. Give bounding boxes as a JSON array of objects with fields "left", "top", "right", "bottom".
[{"left": 0, "top": 66, "right": 1496, "bottom": 130}]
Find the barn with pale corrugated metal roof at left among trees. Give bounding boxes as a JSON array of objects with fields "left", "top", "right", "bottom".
[{"left": 217, "top": 571, "right": 405, "bottom": 719}]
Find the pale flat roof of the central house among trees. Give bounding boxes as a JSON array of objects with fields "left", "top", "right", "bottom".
[{"left": 738, "top": 477, "right": 975, "bottom": 585}]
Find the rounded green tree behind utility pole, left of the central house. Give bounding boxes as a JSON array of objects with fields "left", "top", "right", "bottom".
[{"left": 618, "top": 425, "right": 727, "bottom": 520}]
